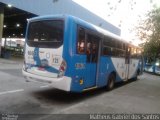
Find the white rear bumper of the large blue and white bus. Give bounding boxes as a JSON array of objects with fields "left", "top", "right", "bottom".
[{"left": 22, "top": 69, "right": 71, "bottom": 91}]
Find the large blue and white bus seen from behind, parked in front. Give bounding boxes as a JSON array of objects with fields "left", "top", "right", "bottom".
[{"left": 22, "top": 15, "right": 143, "bottom": 92}]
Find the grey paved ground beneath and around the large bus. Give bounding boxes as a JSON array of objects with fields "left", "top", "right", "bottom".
[{"left": 0, "top": 58, "right": 160, "bottom": 120}]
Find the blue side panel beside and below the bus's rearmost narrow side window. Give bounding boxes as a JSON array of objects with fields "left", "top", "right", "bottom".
[{"left": 70, "top": 22, "right": 87, "bottom": 92}]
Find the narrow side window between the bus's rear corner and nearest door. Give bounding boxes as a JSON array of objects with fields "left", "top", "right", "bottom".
[{"left": 77, "top": 28, "right": 85, "bottom": 54}]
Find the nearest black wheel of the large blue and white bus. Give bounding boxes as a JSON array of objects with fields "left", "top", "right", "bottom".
[{"left": 107, "top": 73, "right": 115, "bottom": 90}]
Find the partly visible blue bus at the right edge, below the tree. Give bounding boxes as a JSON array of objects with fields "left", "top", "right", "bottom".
[{"left": 144, "top": 56, "right": 160, "bottom": 75}]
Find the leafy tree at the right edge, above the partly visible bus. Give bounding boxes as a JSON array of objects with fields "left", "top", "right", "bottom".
[{"left": 136, "top": 8, "right": 160, "bottom": 58}]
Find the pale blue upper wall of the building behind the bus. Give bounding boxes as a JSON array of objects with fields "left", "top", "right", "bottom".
[{"left": 0, "top": 0, "right": 121, "bottom": 35}]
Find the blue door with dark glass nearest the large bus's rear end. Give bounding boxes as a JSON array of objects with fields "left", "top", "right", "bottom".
[{"left": 85, "top": 35, "right": 100, "bottom": 88}]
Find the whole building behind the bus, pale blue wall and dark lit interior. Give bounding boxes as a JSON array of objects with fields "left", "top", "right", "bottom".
[{"left": 0, "top": 0, "right": 121, "bottom": 56}]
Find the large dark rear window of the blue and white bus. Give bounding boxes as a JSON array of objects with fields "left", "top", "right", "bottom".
[{"left": 27, "top": 20, "right": 64, "bottom": 48}]
